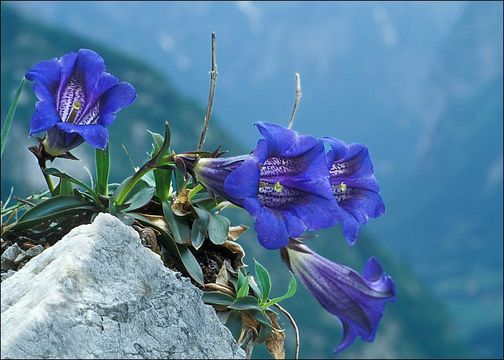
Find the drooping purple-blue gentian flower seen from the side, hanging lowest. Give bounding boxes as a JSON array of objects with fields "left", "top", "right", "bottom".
[{"left": 281, "top": 240, "right": 395, "bottom": 352}]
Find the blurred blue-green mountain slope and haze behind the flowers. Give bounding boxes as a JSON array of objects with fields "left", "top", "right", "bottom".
[{"left": 1, "top": 2, "right": 503, "bottom": 358}]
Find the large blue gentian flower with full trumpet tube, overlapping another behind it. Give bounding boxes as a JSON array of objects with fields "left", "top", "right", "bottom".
[{"left": 183, "top": 123, "right": 344, "bottom": 249}]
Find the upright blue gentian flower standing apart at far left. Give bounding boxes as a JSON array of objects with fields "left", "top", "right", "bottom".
[{"left": 26, "top": 49, "right": 136, "bottom": 156}]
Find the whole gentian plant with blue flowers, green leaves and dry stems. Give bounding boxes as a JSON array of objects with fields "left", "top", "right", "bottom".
[{"left": 1, "top": 34, "right": 395, "bottom": 358}]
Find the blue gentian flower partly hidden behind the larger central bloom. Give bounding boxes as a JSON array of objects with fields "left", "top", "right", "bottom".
[{"left": 324, "top": 137, "right": 385, "bottom": 245}]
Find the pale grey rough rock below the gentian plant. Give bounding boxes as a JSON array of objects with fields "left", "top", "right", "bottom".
[{"left": 1, "top": 214, "right": 244, "bottom": 359}]
